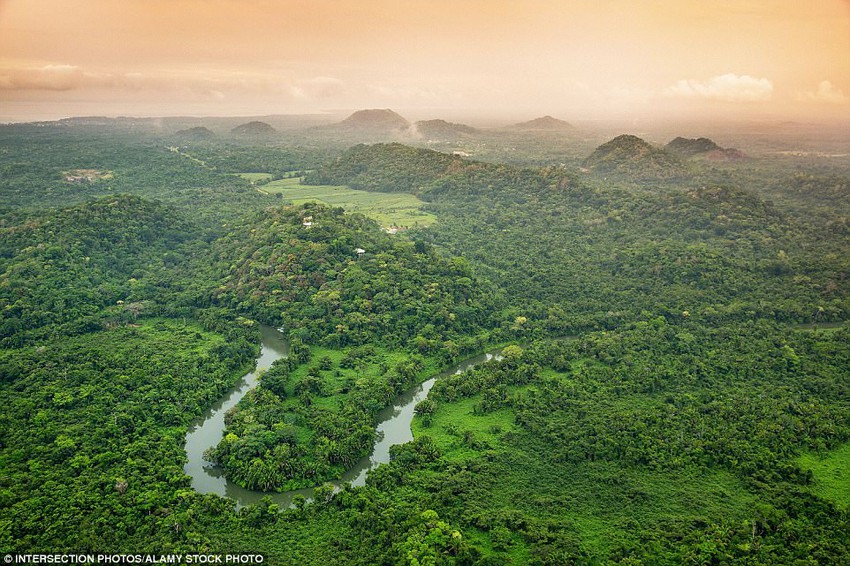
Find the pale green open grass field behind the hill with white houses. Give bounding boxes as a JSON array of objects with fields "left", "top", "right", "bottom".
[{"left": 258, "top": 178, "right": 437, "bottom": 229}]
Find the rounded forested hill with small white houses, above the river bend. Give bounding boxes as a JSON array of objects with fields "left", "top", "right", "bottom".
[{"left": 208, "top": 204, "right": 497, "bottom": 358}]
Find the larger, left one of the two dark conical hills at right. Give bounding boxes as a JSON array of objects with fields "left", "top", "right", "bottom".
[{"left": 584, "top": 135, "right": 684, "bottom": 179}]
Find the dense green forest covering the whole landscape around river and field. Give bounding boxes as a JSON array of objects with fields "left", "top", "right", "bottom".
[{"left": 0, "top": 118, "right": 850, "bottom": 565}]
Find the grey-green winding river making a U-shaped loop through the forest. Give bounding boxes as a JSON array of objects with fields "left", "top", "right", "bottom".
[{"left": 183, "top": 326, "right": 497, "bottom": 507}]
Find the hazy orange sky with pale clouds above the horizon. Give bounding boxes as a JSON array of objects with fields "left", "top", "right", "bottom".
[{"left": 0, "top": 0, "right": 850, "bottom": 122}]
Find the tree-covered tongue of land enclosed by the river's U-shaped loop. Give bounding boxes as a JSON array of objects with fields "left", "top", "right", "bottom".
[{"left": 205, "top": 345, "right": 433, "bottom": 491}]
